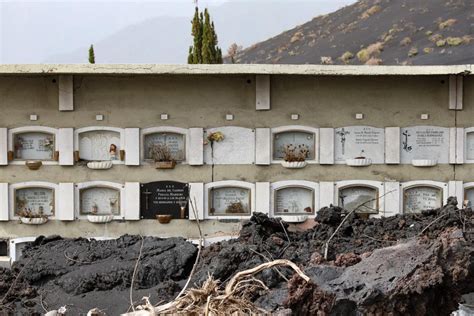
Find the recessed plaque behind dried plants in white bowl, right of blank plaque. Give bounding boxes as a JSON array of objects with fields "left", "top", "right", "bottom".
[{"left": 273, "top": 131, "right": 316, "bottom": 160}]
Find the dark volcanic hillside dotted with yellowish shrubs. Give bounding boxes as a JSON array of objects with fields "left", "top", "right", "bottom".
[{"left": 233, "top": 0, "right": 474, "bottom": 65}]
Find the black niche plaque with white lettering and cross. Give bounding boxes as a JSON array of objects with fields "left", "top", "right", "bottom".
[{"left": 140, "top": 181, "right": 189, "bottom": 219}]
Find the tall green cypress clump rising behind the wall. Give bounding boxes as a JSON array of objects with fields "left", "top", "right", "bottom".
[{"left": 188, "top": 7, "right": 222, "bottom": 64}]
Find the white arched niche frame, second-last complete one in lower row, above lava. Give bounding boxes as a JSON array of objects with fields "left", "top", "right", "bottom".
[{"left": 334, "top": 180, "right": 385, "bottom": 217}]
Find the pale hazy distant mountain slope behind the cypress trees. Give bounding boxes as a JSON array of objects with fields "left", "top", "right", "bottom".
[{"left": 43, "top": 0, "right": 353, "bottom": 64}]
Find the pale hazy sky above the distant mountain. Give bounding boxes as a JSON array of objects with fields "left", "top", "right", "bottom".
[{"left": 0, "top": 0, "right": 355, "bottom": 63}]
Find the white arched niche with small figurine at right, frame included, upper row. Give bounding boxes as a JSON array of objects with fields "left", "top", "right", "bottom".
[{"left": 74, "top": 126, "right": 125, "bottom": 164}]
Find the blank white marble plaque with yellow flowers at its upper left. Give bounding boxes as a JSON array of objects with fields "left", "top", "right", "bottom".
[{"left": 204, "top": 126, "right": 255, "bottom": 165}]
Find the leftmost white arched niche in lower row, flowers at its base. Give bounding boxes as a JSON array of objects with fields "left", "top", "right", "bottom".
[{"left": 9, "top": 181, "right": 59, "bottom": 219}]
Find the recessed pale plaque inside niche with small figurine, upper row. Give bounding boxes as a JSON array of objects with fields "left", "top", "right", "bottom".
[{"left": 79, "top": 131, "right": 121, "bottom": 161}]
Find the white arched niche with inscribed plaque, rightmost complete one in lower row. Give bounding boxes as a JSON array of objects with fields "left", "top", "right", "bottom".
[{"left": 400, "top": 180, "right": 448, "bottom": 214}]
